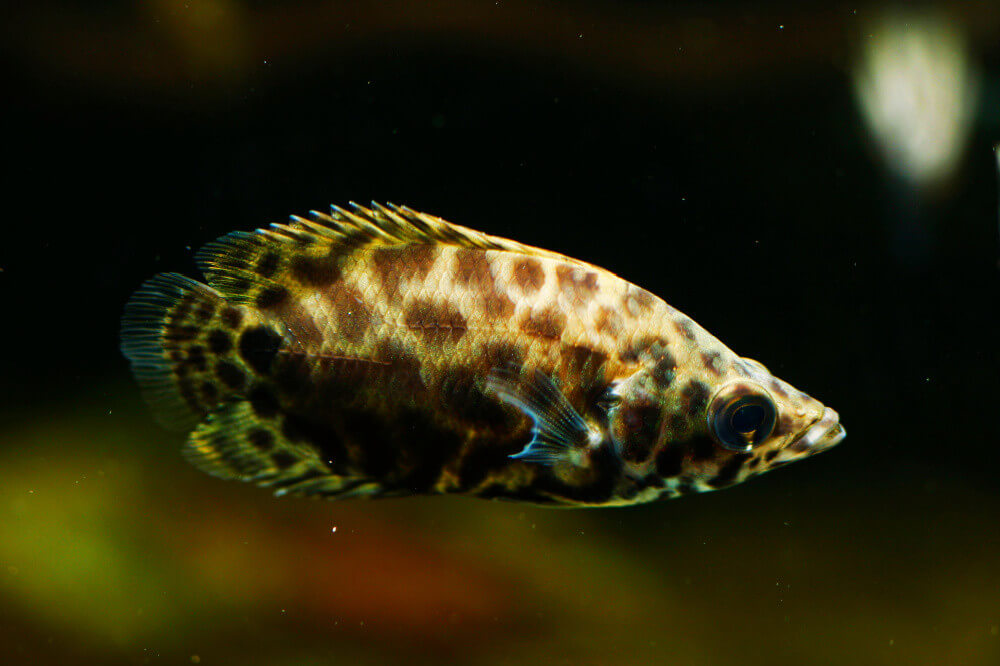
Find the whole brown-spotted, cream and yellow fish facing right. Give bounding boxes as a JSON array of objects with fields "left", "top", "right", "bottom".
[{"left": 121, "top": 202, "right": 846, "bottom": 507}]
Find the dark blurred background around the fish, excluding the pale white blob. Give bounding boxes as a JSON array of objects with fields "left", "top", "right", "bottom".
[{"left": 0, "top": 0, "right": 1000, "bottom": 664}]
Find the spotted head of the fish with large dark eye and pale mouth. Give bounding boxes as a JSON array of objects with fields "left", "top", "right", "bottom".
[{"left": 609, "top": 336, "right": 846, "bottom": 496}]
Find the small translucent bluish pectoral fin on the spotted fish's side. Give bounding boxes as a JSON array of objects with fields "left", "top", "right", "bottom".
[{"left": 485, "top": 369, "right": 603, "bottom": 465}]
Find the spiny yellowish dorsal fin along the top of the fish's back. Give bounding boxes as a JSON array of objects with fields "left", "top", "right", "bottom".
[{"left": 195, "top": 202, "right": 584, "bottom": 305}]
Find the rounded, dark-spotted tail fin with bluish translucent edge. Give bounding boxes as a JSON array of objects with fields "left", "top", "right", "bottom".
[{"left": 121, "top": 273, "right": 281, "bottom": 430}]
